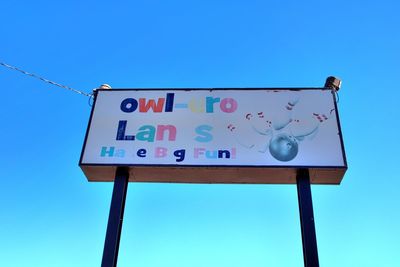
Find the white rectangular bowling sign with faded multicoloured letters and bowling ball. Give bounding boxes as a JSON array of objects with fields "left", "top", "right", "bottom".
[{"left": 80, "top": 89, "right": 347, "bottom": 184}]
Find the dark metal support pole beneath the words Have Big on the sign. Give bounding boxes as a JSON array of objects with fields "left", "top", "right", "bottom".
[{"left": 101, "top": 167, "right": 129, "bottom": 267}]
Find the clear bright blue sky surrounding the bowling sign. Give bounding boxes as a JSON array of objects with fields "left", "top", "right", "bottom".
[{"left": 0, "top": 0, "right": 400, "bottom": 267}]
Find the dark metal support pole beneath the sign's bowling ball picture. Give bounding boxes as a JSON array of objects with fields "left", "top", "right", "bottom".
[{"left": 296, "top": 169, "right": 319, "bottom": 267}]
